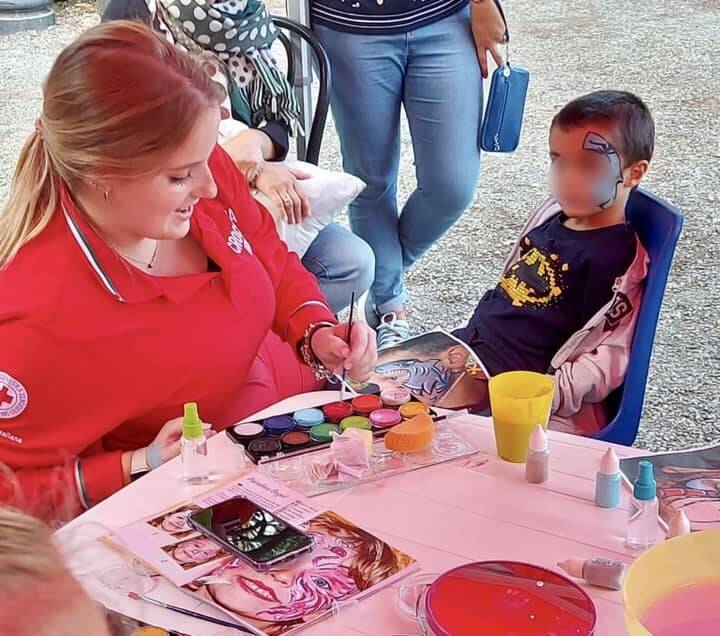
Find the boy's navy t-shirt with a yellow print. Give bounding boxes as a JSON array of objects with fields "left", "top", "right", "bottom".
[{"left": 455, "top": 213, "right": 637, "bottom": 375}]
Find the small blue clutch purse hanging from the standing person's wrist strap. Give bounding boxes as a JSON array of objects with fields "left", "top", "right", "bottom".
[{"left": 480, "top": 0, "right": 530, "bottom": 152}]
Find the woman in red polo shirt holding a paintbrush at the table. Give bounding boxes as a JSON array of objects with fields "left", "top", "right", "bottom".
[{"left": 0, "top": 22, "right": 376, "bottom": 519}]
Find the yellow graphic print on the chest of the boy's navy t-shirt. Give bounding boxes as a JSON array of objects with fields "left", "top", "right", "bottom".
[{"left": 500, "top": 236, "right": 570, "bottom": 308}]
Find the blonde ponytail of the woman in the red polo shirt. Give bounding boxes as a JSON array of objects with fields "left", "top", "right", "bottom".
[{"left": 0, "top": 126, "right": 59, "bottom": 269}]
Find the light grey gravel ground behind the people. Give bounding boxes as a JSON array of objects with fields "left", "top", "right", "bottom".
[{"left": 0, "top": 0, "right": 720, "bottom": 450}]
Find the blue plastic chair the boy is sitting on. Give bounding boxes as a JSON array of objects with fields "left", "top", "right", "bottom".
[{"left": 594, "top": 189, "right": 683, "bottom": 446}]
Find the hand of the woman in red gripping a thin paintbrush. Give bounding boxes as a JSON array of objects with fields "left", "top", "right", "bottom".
[{"left": 310, "top": 321, "right": 377, "bottom": 382}]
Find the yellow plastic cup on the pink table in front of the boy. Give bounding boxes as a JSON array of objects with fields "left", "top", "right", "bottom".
[{"left": 489, "top": 371, "right": 555, "bottom": 463}]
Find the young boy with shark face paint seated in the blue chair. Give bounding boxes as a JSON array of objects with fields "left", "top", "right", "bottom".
[{"left": 454, "top": 91, "right": 655, "bottom": 433}]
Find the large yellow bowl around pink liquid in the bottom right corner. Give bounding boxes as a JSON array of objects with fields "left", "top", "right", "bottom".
[{"left": 622, "top": 530, "right": 720, "bottom": 636}]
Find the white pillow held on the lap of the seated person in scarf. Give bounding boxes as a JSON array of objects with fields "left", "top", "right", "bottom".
[{"left": 218, "top": 119, "right": 366, "bottom": 258}]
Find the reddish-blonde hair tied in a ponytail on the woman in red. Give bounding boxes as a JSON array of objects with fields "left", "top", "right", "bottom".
[{"left": 0, "top": 21, "right": 223, "bottom": 269}]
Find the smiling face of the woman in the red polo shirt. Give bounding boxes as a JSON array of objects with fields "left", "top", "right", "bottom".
[{"left": 93, "top": 107, "right": 220, "bottom": 242}]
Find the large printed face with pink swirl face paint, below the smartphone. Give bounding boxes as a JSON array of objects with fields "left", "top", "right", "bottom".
[{"left": 208, "top": 532, "right": 357, "bottom": 622}]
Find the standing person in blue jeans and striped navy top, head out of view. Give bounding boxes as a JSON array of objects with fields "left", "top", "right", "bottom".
[{"left": 310, "top": 0, "right": 504, "bottom": 347}]
